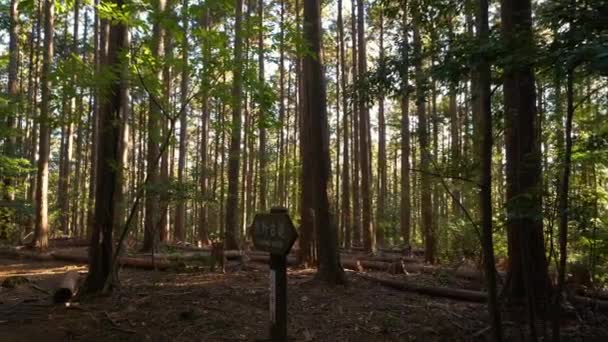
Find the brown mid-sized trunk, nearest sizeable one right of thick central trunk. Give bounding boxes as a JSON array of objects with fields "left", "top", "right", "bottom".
[{"left": 357, "top": 0, "right": 376, "bottom": 253}]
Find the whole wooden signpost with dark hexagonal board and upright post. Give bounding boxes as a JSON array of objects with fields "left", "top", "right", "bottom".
[{"left": 253, "top": 207, "right": 298, "bottom": 342}]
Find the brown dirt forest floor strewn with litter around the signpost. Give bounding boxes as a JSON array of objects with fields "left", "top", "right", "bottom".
[{"left": 0, "top": 259, "right": 608, "bottom": 342}]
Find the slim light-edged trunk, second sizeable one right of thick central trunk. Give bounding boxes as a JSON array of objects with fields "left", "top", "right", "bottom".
[{"left": 376, "top": 8, "right": 388, "bottom": 246}]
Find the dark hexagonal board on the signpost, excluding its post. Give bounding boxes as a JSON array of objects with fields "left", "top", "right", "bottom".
[{"left": 253, "top": 213, "right": 298, "bottom": 255}]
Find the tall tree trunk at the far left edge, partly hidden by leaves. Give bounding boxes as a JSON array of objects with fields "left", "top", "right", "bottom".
[{"left": 2, "top": 0, "right": 19, "bottom": 201}]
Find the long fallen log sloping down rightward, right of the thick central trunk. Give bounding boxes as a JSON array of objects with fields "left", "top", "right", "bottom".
[{"left": 359, "top": 273, "right": 487, "bottom": 303}]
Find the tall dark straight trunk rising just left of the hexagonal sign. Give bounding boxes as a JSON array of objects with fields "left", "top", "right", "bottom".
[{"left": 224, "top": 0, "right": 243, "bottom": 249}]
